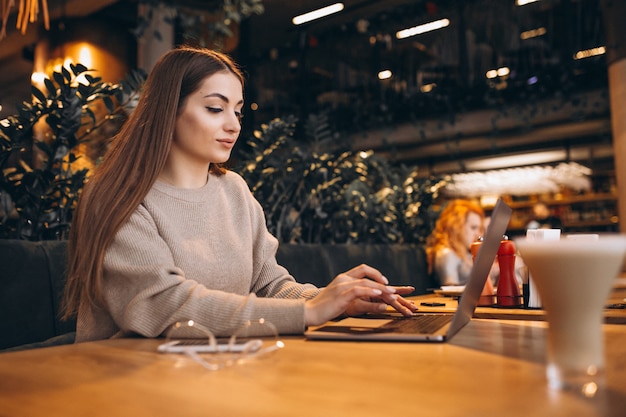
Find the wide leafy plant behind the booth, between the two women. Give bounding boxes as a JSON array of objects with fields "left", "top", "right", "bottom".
[{"left": 236, "top": 116, "right": 446, "bottom": 243}]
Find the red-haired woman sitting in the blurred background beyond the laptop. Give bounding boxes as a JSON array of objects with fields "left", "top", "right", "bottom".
[{"left": 426, "top": 199, "right": 485, "bottom": 285}]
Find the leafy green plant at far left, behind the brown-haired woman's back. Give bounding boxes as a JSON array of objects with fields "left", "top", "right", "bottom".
[{"left": 0, "top": 64, "right": 145, "bottom": 240}]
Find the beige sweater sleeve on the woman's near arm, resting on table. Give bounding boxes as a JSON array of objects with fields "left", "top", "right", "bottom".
[{"left": 96, "top": 207, "right": 305, "bottom": 337}]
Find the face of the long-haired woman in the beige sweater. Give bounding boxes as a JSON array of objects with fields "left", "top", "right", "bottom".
[{"left": 169, "top": 72, "right": 243, "bottom": 170}]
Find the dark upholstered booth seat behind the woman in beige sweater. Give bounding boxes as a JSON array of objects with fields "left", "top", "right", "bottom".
[{"left": 0, "top": 239, "right": 434, "bottom": 350}]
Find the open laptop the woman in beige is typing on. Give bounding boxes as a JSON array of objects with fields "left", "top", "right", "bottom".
[{"left": 304, "top": 199, "right": 512, "bottom": 342}]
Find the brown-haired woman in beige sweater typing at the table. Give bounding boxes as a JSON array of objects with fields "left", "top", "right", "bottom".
[{"left": 65, "top": 47, "right": 416, "bottom": 342}]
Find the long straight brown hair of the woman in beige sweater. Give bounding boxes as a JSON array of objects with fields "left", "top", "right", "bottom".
[{"left": 63, "top": 46, "right": 244, "bottom": 319}]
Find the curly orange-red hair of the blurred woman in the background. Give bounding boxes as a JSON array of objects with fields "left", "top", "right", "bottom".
[{"left": 426, "top": 199, "right": 485, "bottom": 272}]
